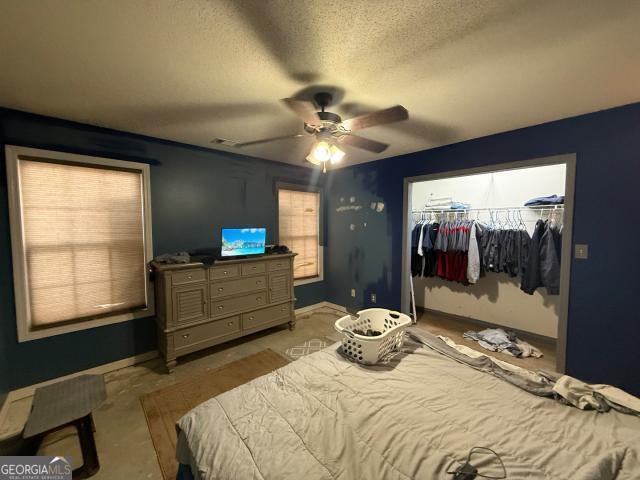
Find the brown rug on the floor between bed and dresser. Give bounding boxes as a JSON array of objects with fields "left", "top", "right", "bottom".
[{"left": 140, "top": 349, "right": 289, "bottom": 480}]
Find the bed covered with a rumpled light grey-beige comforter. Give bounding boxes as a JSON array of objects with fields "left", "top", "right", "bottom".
[{"left": 177, "top": 330, "right": 640, "bottom": 480}]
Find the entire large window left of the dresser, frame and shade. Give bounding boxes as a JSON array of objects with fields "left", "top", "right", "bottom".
[{"left": 6, "top": 146, "right": 153, "bottom": 341}]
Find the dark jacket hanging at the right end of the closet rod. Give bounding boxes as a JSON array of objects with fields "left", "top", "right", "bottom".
[{"left": 520, "top": 220, "right": 562, "bottom": 295}]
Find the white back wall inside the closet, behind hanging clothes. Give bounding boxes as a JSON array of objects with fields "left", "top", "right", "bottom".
[{"left": 410, "top": 165, "right": 566, "bottom": 338}]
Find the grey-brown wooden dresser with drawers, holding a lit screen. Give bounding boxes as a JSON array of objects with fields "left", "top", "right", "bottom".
[{"left": 152, "top": 253, "right": 295, "bottom": 372}]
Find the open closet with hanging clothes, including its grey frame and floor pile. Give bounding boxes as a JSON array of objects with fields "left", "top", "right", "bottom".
[{"left": 401, "top": 155, "right": 575, "bottom": 373}]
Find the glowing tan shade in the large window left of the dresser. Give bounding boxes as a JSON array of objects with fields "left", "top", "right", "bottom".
[{"left": 19, "top": 159, "right": 147, "bottom": 328}]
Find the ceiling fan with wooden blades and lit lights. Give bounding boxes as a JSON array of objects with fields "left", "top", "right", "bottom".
[{"left": 235, "top": 92, "right": 409, "bottom": 172}]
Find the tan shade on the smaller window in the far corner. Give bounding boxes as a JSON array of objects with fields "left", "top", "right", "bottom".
[{"left": 278, "top": 189, "right": 320, "bottom": 279}]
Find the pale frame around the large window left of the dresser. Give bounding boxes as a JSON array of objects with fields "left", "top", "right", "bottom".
[{"left": 5, "top": 145, "right": 155, "bottom": 342}]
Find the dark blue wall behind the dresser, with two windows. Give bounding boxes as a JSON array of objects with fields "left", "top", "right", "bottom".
[{"left": 0, "top": 109, "right": 327, "bottom": 394}]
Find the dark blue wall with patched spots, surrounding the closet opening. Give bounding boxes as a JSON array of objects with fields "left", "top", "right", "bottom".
[{"left": 326, "top": 104, "right": 640, "bottom": 394}]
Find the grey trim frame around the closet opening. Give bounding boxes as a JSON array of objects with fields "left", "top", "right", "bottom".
[{"left": 400, "top": 153, "right": 576, "bottom": 373}]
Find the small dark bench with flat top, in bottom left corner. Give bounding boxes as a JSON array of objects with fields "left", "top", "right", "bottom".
[{"left": 22, "top": 375, "right": 107, "bottom": 479}]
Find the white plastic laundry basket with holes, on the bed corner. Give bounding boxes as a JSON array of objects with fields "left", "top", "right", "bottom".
[{"left": 335, "top": 308, "right": 411, "bottom": 365}]
